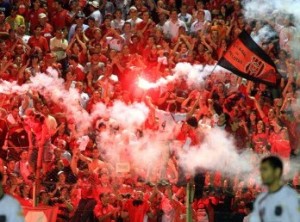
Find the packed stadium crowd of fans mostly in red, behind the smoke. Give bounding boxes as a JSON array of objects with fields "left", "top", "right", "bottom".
[{"left": 0, "top": 0, "right": 300, "bottom": 222}]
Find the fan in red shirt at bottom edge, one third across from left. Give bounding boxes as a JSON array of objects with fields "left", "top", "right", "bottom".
[{"left": 94, "top": 193, "right": 117, "bottom": 222}]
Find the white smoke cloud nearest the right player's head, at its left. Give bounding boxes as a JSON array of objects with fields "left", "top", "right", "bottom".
[{"left": 180, "top": 128, "right": 255, "bottom": 178}]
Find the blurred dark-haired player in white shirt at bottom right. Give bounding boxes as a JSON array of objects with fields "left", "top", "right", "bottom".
[{"left": 250, "top": 156, "right": 300, "bottom": 222}]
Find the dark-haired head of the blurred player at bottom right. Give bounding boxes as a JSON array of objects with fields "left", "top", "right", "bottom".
[{"left": 260, "top": 156, "right": 283, "bottom": 186}]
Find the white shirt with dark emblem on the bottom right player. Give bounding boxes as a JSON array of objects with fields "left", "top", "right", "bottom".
[{"left": 250, "top": 185, "right": 300, "bottom": 222}]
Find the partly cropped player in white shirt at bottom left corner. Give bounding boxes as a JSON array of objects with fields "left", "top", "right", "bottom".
[{"left": 0, "top": 172, "right": 24, "bottom": 222}]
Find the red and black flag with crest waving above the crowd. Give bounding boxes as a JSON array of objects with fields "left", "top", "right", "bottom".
[{"left": 218, "top": 30, "right": 280, "bottom": 86}]
